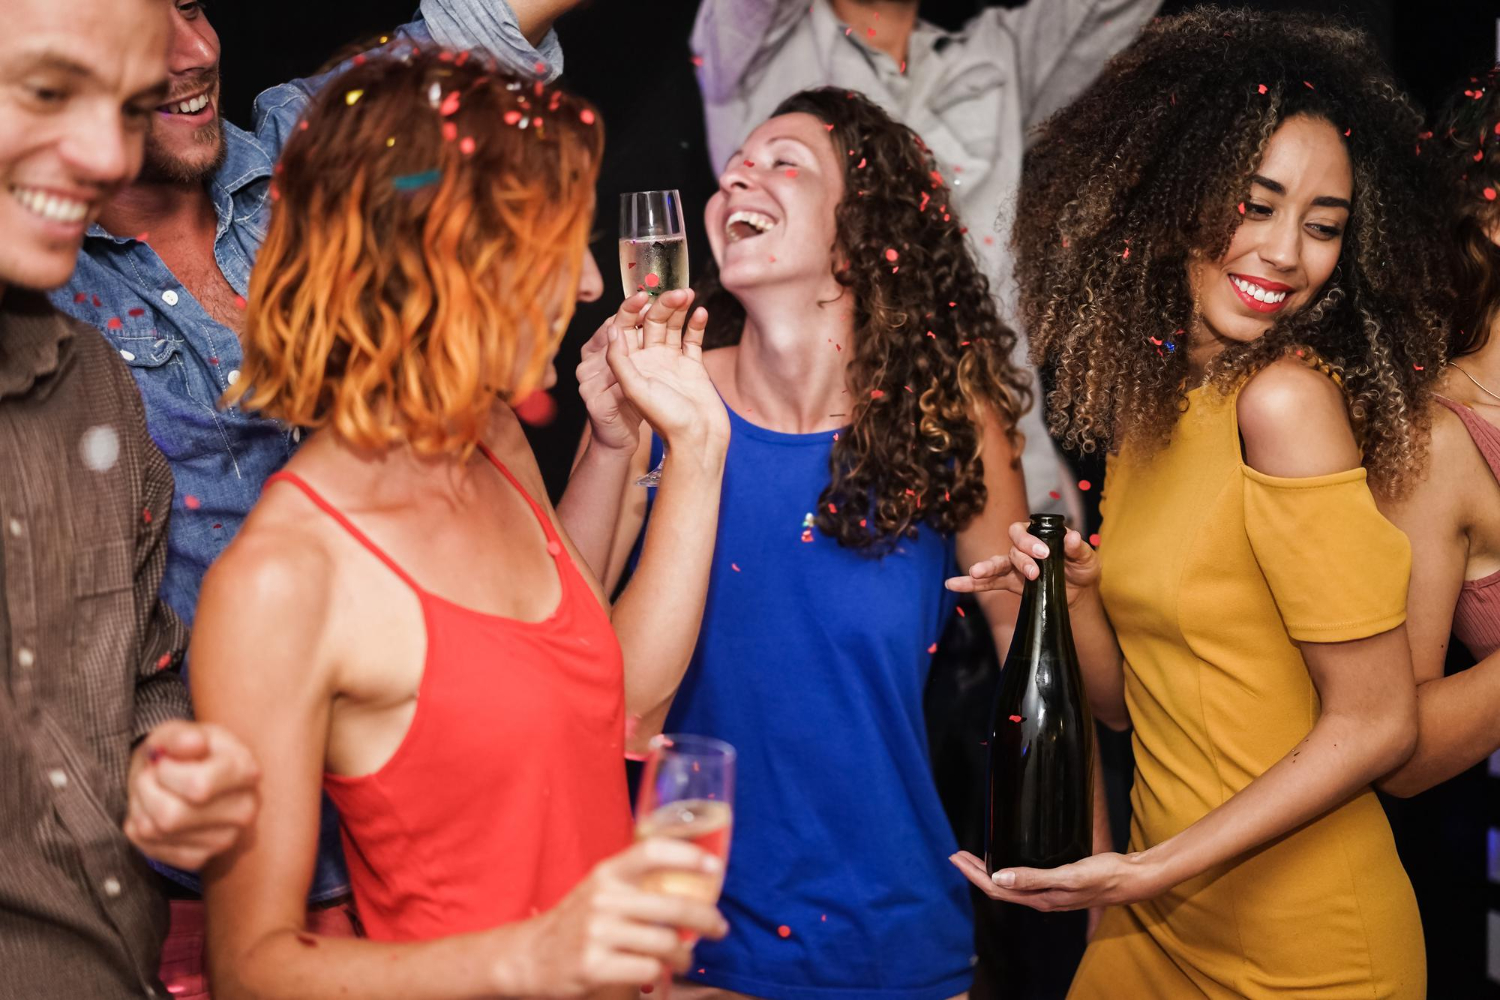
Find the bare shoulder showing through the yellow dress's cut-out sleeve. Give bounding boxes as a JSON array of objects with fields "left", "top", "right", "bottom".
[{"left": 1235, "top": 357, "right": 1359, "bottom": 478}]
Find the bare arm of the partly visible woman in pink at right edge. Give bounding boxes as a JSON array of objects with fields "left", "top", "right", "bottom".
[{"left": 1380, "top": 405, "right": 1500, "bottom": 796}]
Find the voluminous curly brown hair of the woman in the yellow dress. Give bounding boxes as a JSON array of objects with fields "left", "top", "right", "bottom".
[{"left": 1013, "top": 6, "right": 1451, "bottom": 493}]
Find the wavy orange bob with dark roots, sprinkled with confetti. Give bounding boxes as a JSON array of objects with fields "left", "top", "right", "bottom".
[{"left": 225, "top": 49, "right": 603, "bottom": 454}]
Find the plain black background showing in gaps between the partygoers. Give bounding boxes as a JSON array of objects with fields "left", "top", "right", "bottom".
[{"left": 210, "top": 0, "right": 1500, "bottom": 1000}]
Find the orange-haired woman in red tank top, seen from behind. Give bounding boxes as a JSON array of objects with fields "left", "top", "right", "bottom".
[{"left": 192, "top": 52, "right": 728, "bottom": 1000}]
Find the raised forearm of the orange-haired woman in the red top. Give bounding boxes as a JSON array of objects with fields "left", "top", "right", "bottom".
[{"left": 612, "top": 442, "right": 725, "bottom": 736}]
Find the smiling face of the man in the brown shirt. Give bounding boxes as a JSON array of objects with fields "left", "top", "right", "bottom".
[{"left": 0, "top": 0, "right": 167, "bottom": 289}]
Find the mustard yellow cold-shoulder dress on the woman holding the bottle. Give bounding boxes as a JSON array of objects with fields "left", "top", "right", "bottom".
[{"left": 1068, "top": 379, "right": 1427, "bottom": 1000}]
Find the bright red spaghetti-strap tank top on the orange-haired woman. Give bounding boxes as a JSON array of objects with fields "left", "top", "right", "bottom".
[{"left": 270, "top": 445, "right": 632, "bottom": 940}]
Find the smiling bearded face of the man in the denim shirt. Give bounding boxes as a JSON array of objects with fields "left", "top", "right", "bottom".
[{"left": 141, "top": 0, "right": 225, "bottom": 183}]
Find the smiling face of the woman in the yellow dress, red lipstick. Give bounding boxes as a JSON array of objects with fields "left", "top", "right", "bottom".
[{"left": 1188, "top": 115, "right": 1355, "bottom": 354}]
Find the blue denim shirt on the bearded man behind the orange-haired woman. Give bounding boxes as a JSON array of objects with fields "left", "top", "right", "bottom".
[{"left": 53, "top": 0, "right": 563, "bottom": 903}]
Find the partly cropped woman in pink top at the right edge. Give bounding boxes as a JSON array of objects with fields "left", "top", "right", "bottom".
[{"left": 1382, "top": 66, "right": 1500, "bottom": 796}]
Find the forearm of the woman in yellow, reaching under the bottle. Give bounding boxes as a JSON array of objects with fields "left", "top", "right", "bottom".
[{"left": 1134, "top": 715, "right": 1410, "bottom": 891}]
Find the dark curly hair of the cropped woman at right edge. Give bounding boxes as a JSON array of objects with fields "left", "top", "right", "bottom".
[{"left": 1428, "top": 64, "right": 1500, "bottom": 357}]
